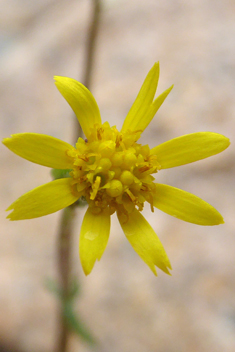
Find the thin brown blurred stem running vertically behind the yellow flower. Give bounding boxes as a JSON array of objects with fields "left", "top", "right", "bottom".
[{"left": 56, "top": 0, "right": 100, "bottom": 352}]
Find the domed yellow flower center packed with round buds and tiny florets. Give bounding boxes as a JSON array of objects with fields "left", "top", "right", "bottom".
[{"left": 67, "top": 122, "right": 160, "bottom": 215}]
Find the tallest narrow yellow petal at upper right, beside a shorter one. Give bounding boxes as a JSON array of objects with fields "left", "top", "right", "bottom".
[{"left": 121, "top": 62, "right": 159, "bottom": 132}]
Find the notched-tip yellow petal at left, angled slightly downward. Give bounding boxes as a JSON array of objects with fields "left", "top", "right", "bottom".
[{"left": 7, "top": 178, "right": 78, "bottom": 220}]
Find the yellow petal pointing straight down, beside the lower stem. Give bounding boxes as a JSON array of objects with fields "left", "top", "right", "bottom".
[{"left": 79, "top": 208, "right": 110, "bottom": 275}]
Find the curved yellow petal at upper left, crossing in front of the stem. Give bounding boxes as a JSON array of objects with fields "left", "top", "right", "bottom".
[{"left": 54, "top": 76, "right": 101, "bottom": 138}]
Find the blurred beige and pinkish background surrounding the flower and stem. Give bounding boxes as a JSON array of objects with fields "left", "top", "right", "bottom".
[{"left": 0, "top": 0, "right": 235, "bottom": 352}]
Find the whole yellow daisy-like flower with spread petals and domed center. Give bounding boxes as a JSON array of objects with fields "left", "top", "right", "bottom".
[{"left": 3, "top": 63, "right": 229, "bottom": 275}]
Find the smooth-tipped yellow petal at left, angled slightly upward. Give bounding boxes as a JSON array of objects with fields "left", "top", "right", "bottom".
[{"left": 3, "top": 133, "right": 74, "bottom": 169}]
